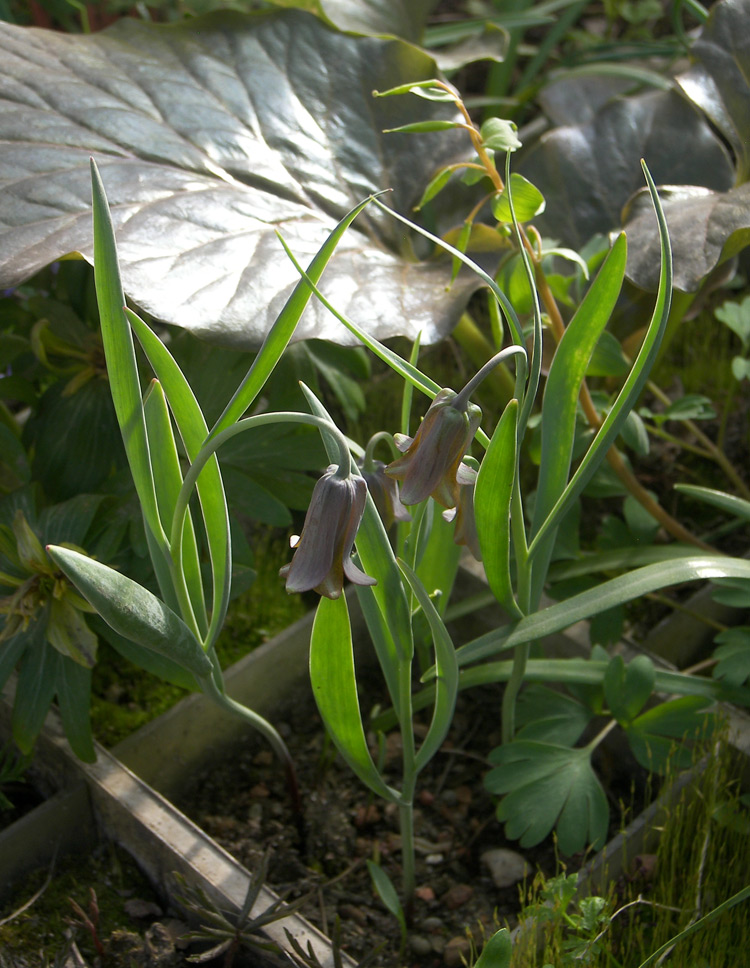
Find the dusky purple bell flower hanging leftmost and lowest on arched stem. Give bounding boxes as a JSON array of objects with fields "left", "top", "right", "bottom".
[{"left": 279, "top": 464, "right": 375, "bottom": 598}]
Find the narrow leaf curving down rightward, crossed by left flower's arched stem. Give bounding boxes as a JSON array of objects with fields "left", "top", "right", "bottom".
[{"left": 128, "top": 311, "right": 232, "bottom": 648}]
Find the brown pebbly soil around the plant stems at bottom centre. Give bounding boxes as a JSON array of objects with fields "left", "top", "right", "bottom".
[{"left": 179, "top": 672, "right": 643, "bottom": 968}]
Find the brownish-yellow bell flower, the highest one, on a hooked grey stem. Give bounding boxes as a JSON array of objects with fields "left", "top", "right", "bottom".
[{"left": 385, "top": 388, "right": 482, "bottom": 508}]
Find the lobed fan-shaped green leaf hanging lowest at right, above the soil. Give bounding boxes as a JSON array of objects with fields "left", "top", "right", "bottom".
[{"left": 485, "top": 740, "right": 609, "bottom": 854}]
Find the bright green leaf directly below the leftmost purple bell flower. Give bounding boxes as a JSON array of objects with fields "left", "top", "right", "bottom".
[{"left": 310, "top": 596, "right": 399, "bottom": 802}]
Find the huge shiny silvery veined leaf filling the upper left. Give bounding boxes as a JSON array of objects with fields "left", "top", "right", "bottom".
[{"left": 0, "top": 10, "right": 477, "bottom": 348}]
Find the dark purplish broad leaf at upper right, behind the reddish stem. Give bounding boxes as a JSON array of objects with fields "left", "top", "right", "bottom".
[{"left": 520, "top": 91, "right": 734, "bottom": 251}]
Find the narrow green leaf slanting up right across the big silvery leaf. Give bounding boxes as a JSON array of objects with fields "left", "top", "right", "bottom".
[{"left": 211, "top": 196, "right": 382, "bottom": 437}]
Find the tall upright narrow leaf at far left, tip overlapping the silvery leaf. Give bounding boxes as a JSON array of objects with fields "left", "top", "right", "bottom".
[{"left": 91, "top": 159, "right": 165, "bottom": 541}]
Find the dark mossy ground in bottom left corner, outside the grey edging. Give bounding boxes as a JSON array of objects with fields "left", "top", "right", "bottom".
[{"left": 0, "top": 844, "right": 159, "bottom": 968}]
